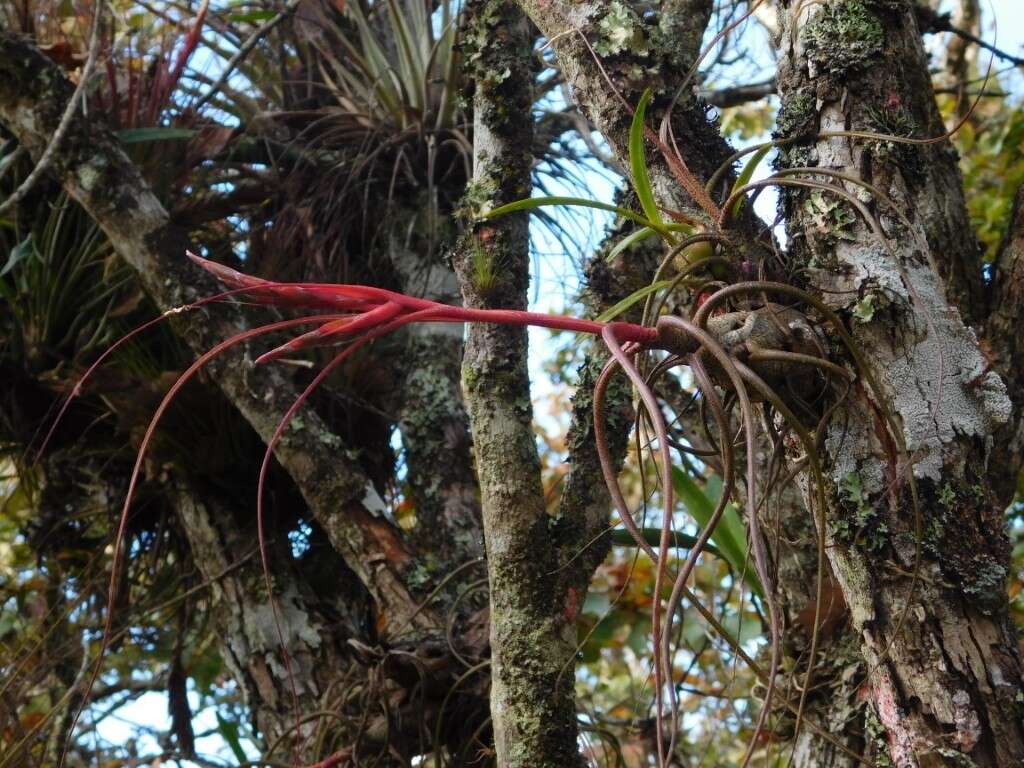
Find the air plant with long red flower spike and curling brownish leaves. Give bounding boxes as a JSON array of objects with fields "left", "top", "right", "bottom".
[{"left": 44, "top": 254, "right": 860, "bottom": 768}]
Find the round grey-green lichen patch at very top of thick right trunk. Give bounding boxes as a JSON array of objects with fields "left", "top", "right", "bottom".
[{"left": 800, "top": 0, "right": 885, "bottom": 77}]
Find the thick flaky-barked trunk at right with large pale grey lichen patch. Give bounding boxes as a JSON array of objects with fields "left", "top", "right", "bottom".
[{"left": 778, "top": 0, "right": 1024, "bottom": 768}]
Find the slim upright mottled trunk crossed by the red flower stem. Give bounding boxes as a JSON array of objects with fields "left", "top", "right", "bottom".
[{"left": 455, "top": 0, "right": 581, "bottom": 768}]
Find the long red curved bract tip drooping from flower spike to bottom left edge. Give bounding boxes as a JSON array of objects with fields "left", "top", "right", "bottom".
[{"left": 58, "top": 314, "right": 345, "bottom": 765}]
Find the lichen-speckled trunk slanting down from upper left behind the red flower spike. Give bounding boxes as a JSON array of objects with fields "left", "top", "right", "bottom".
[{"left": 0, "top": 34, "right": 440, "bottom": 640}]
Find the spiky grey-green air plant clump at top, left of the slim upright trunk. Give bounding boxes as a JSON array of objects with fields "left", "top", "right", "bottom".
[{"left": 251, "top": 0, "right": 472, "bottom": 274}]
